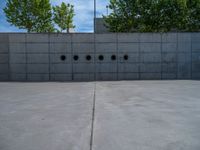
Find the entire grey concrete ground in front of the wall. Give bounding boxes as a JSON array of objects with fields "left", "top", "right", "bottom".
[{"left": 0, "top": 81, "right": 200, "bottom": 150}]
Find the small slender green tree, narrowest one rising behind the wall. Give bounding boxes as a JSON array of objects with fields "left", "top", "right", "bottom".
[{"left": 53, "top": 2, "right": 75, "bottom": 33}]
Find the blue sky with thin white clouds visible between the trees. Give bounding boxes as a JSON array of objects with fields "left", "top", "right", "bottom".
[{"left": 0, "top": 0, "right": 109, "bottom": 32}]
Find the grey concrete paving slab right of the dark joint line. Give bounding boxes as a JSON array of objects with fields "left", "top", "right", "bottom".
[{"left": 93, "top": 81, "right": 200, "bottom": 150}]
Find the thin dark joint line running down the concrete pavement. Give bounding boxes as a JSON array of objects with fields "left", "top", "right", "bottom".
[{"left": 90, "top": 82, "right": 96, "bottom": 150}]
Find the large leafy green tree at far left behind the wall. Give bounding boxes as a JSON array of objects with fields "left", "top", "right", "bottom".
[{"left": 4, "top": 0, "right": 54, "bottom": 32}]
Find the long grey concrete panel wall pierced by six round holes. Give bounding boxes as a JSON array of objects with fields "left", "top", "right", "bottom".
[{"left": 0, "top": 33, "right": 200, "bottom": 81}]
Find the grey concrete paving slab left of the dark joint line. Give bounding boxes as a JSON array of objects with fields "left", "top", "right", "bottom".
[{"left": 0, "top": 83, "right": 94, "bottom": 150}]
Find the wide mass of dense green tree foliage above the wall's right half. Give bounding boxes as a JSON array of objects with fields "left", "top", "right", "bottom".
[{"left": 103, "top": 0, "right": 200, "bottom": 32}]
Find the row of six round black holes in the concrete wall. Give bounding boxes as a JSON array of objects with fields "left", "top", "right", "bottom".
[{"left": 60, "top": 55, "right": 128, "bottom": 61}]
